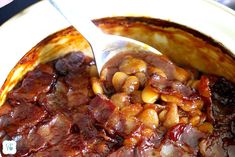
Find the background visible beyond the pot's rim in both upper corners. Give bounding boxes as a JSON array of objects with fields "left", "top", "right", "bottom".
[{"left": 0, "top": 0, "right": 235, "bottom": 25}]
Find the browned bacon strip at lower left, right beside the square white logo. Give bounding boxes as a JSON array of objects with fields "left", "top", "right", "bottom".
[{"left": 12, "top": 114, "right": 71, "bottom": 156}]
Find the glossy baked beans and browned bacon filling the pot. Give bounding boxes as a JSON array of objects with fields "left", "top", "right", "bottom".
[{"left": 0, "top": 52, "right": 235, "bottom": 157}]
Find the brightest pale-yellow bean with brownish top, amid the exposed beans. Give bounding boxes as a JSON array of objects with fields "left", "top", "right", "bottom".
[{"left": 141, "top": 86, "right": 159, "bottom": 103}]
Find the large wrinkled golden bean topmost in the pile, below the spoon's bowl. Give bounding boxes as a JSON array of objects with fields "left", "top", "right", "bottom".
[{"left": 119, "top": 56, "right": 147, "bottom": 74}]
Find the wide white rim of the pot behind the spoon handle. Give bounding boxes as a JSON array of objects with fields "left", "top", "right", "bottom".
[{"left": 0, "top": 0, "right": 235, "bottom": 85}]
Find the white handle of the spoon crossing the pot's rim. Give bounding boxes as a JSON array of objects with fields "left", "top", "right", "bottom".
[{"left": 49, "top": 0, "right": 104, "bottom": 48}]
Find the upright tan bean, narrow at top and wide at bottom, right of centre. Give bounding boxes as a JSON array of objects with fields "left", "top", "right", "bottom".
[{"left": 163, "top": 103, "right": 179, "bottom": 128}]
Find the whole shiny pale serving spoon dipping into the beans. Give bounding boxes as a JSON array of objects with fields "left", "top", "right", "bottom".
[{"left": 49, "top": 0, "right": 161, "bottom": 74}]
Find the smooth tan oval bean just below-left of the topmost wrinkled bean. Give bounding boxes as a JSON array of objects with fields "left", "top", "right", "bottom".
[{"left": 112, "top": 72, "right": 128, "bottom": 91}]
